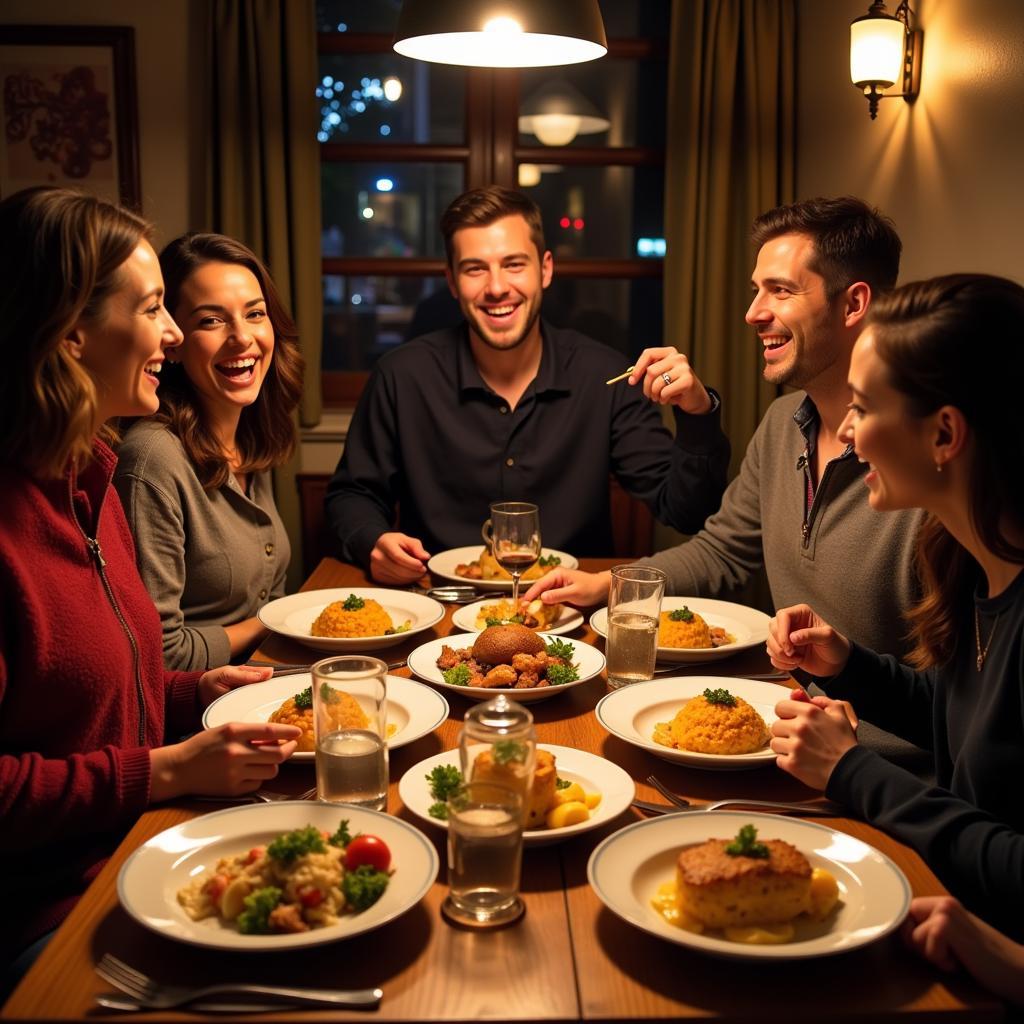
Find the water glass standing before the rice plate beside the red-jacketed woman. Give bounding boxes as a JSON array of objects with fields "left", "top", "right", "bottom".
[{"left": 312, "top": 654, "right": 388, "bottom": 811}]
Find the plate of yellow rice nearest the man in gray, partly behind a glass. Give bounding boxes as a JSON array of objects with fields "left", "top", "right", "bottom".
[{"left": 590, "top": 597, "right": 770, "bottom": 665}]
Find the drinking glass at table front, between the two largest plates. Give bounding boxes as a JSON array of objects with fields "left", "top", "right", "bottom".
[{"left": 441, "top": 781, "right": 523, "bottom": 928}]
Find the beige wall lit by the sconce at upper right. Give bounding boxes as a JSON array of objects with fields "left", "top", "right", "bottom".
[{"left": 797, "top": 0, "right": 1024, "bottom": 283}]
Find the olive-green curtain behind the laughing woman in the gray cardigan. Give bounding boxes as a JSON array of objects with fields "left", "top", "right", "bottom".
[{"left": 206, "top": 0, "right": 323, "bottom": 590}]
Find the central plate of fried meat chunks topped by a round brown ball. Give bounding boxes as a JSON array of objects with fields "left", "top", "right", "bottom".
[{"left": 409, "top": 624, "right": 604, "bottom": 703}]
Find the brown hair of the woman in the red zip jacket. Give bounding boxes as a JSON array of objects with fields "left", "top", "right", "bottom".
[{"left": 0, "top": 186, "right": 152, "bottom": 478}]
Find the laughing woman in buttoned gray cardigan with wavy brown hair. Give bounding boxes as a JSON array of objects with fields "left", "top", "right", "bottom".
[{"left": 115, "top": 234, "right": 302, "bottom": 670}]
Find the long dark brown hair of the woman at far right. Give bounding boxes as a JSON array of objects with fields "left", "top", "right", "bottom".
[{"left": 868, "top": 273, "right": 1024, "bottom": 668}]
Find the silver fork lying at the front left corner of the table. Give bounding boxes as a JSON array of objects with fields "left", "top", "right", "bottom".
[{"left": 95, "top": 953, "right": 384, "bottom": 1010}]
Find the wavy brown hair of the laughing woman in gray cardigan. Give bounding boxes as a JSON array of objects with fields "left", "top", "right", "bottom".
[{"left": 157, "top": 234, "right": 303, "bottom": 488}]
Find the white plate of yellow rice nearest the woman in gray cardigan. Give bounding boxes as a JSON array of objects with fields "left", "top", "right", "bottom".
[{"left": 259, "top": 587, "right": 444, "bottom": 653}]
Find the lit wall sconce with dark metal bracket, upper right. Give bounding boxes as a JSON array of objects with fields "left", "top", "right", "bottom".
[{"left": 850, "top": 0, "right": 924, "bottom": 121}]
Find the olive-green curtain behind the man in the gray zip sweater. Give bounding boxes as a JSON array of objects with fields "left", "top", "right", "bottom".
[{"left": 665, "top": 0, "right": 797, "bottom": 471}]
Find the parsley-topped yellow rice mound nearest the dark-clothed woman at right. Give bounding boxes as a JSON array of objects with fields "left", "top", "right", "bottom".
[{"left": 652, "top": 690, "right": 768, "bottom": 755}]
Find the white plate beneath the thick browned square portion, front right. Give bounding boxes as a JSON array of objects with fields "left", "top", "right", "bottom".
[{"left": 587, "top": 811, "right": 910, "bottom": 961}]
